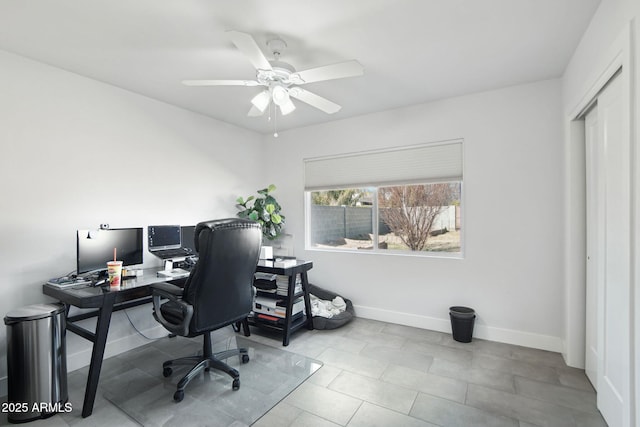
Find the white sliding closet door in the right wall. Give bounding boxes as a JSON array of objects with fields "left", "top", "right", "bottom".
[{"left": 587, "top": 78, "right": 631, "bottom": 426}]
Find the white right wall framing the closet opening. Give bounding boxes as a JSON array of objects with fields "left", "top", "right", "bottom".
[{"left": 562, "top": 0, "right": 640, "bottom": 423}]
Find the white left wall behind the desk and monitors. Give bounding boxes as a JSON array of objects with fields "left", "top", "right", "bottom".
[{"left": 0, "top": 51, "right": 264, "bottom": 395}]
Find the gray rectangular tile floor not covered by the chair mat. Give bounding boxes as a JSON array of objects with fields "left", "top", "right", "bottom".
[{"left": 0, "top": 319, "right": 606, "bottom": 427}]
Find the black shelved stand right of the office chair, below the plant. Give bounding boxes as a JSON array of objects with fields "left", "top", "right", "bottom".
[{"left": 252, "top": 260, "right": 313, "bottom": 346}]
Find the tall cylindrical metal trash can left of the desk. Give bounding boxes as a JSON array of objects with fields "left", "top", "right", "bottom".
[{"left": 4, "top": 304, "right": 69, "bottom": 423}]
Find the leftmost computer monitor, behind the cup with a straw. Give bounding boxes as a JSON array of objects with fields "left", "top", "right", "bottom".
[{"left": 77, "top": 228, "right": 144, "bottom": 274}]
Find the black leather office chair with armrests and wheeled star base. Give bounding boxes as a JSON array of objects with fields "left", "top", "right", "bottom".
[{"left": 152, "top": 218, "right": 262, "bottom": 402}]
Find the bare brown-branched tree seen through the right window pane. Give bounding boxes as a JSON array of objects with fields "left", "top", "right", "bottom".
[{"left": 378, "top": 183, "right": 460, "bottom": 251}]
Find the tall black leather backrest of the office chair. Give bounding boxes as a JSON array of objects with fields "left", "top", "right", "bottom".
[{"left": 183, "top": 218, "right": 262, "bottom": 335}]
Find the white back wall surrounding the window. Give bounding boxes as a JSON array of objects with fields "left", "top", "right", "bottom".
[{"left": 265, "top": 80, "right": 564, "bottom": 351}]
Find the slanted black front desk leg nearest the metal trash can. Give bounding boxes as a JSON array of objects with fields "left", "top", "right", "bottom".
[{"left": 82, "top": 293, "right": 115, "bottom": 418}]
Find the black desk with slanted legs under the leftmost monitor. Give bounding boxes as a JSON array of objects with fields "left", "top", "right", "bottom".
[{"left": 42, "top": 268, "right": 186, "bottom": 418}]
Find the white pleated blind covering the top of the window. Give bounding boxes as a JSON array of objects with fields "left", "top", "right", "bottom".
[{"left": 304, "top": 140, "right": 462, "bottom": 191}]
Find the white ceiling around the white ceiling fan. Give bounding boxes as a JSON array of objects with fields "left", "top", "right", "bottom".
[{"left": 0, "top": 0, "right": 600, "bottom": 133}]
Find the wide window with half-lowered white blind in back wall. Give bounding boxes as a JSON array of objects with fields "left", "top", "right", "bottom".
[{"left": 305, "top": 141, "right": 462, "bottom": 255}]
